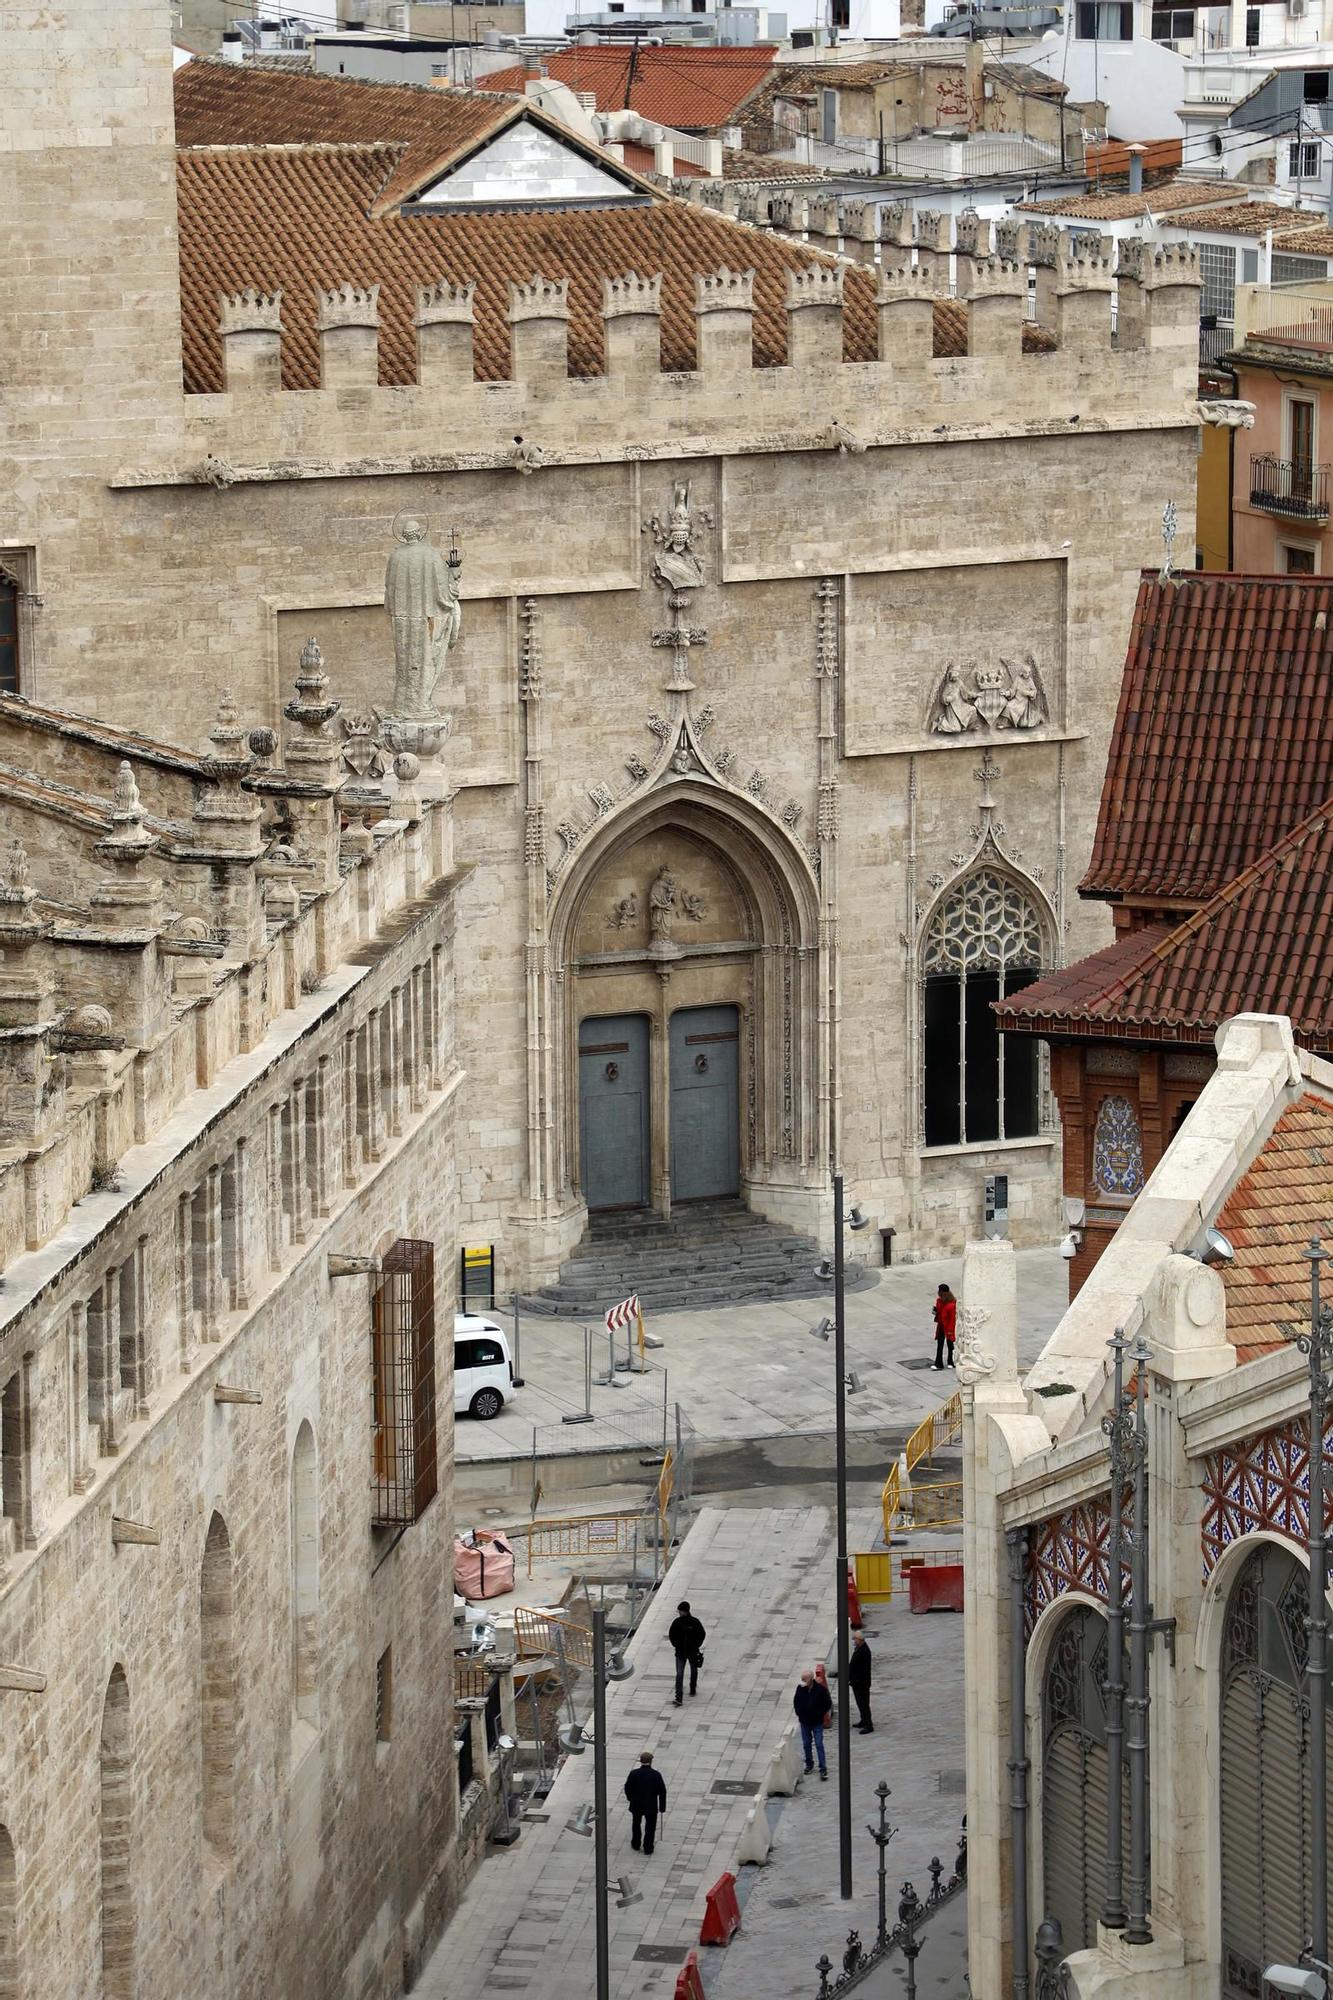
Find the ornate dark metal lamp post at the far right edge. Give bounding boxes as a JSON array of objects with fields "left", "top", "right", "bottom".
[{"left": 1297, "top": 1236, "right": 1333, "bottom": 1962}]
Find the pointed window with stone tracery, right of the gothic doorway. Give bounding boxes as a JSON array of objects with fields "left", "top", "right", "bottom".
[{"left": 923, "top": 868, "right": 1043, "bottom": 1146}]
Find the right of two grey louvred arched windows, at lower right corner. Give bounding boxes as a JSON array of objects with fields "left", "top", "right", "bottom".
[{"left": 1219, "top": 1542, "right": 1333, "bottom": 2000}]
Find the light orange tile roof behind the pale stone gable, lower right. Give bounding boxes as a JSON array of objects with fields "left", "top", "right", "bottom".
[{"left": 1217, "top": 1090, "right": 1333, "bottom": 1362}]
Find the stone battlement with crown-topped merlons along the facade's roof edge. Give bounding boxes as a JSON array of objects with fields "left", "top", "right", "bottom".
[{"left": 174, "top": 237, "right": 1199, "bottom": 482}]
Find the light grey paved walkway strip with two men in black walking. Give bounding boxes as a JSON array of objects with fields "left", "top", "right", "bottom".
[{"left": 414, "top": 1508, "right": 837, "bottom": 2000}]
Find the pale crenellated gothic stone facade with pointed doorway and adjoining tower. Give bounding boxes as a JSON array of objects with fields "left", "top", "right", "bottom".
[{"left": 0, "top": 8, "right": 1197, "bottom": 1282}]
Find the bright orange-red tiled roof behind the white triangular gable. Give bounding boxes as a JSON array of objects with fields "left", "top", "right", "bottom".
[{"left": 478, "top": 42, "right": 775, "bottom": 132}]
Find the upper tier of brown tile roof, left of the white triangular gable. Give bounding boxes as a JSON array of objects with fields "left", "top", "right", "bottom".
[{"left": 174, "top": 62, "right": 528, "bottom": 208}]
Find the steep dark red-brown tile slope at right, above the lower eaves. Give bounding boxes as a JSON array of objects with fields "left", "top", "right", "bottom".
[{"left": 1079, "top": 570, "right": 1333, "bottom": 904}]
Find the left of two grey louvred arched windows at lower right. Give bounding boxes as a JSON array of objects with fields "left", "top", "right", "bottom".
[{"left": 1041, "top": 1604, "right": 1129, "bottom": 1952}]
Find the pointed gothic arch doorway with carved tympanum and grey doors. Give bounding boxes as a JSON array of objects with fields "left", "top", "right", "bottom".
[{"left": 544, "top": 780, "right": 829, "bottom": 1226}]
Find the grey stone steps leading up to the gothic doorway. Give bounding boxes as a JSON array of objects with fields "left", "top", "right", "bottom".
[{"left": 526, "top": 1202, "right": 827, "bottom": 1318}]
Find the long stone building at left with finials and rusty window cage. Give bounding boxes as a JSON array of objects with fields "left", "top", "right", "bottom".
[{"left": 0, "top": 654, "right": 466, "bottom": 2000}]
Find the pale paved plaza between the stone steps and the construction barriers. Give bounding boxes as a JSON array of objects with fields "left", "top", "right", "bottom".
[{"left": 454, "top": 1250, "right": 1067, "bottom": 1464}]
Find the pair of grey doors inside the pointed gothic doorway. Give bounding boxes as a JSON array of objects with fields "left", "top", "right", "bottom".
[{"left": 578, "top": 1006, "right": 741, "bottom": 1208}]
